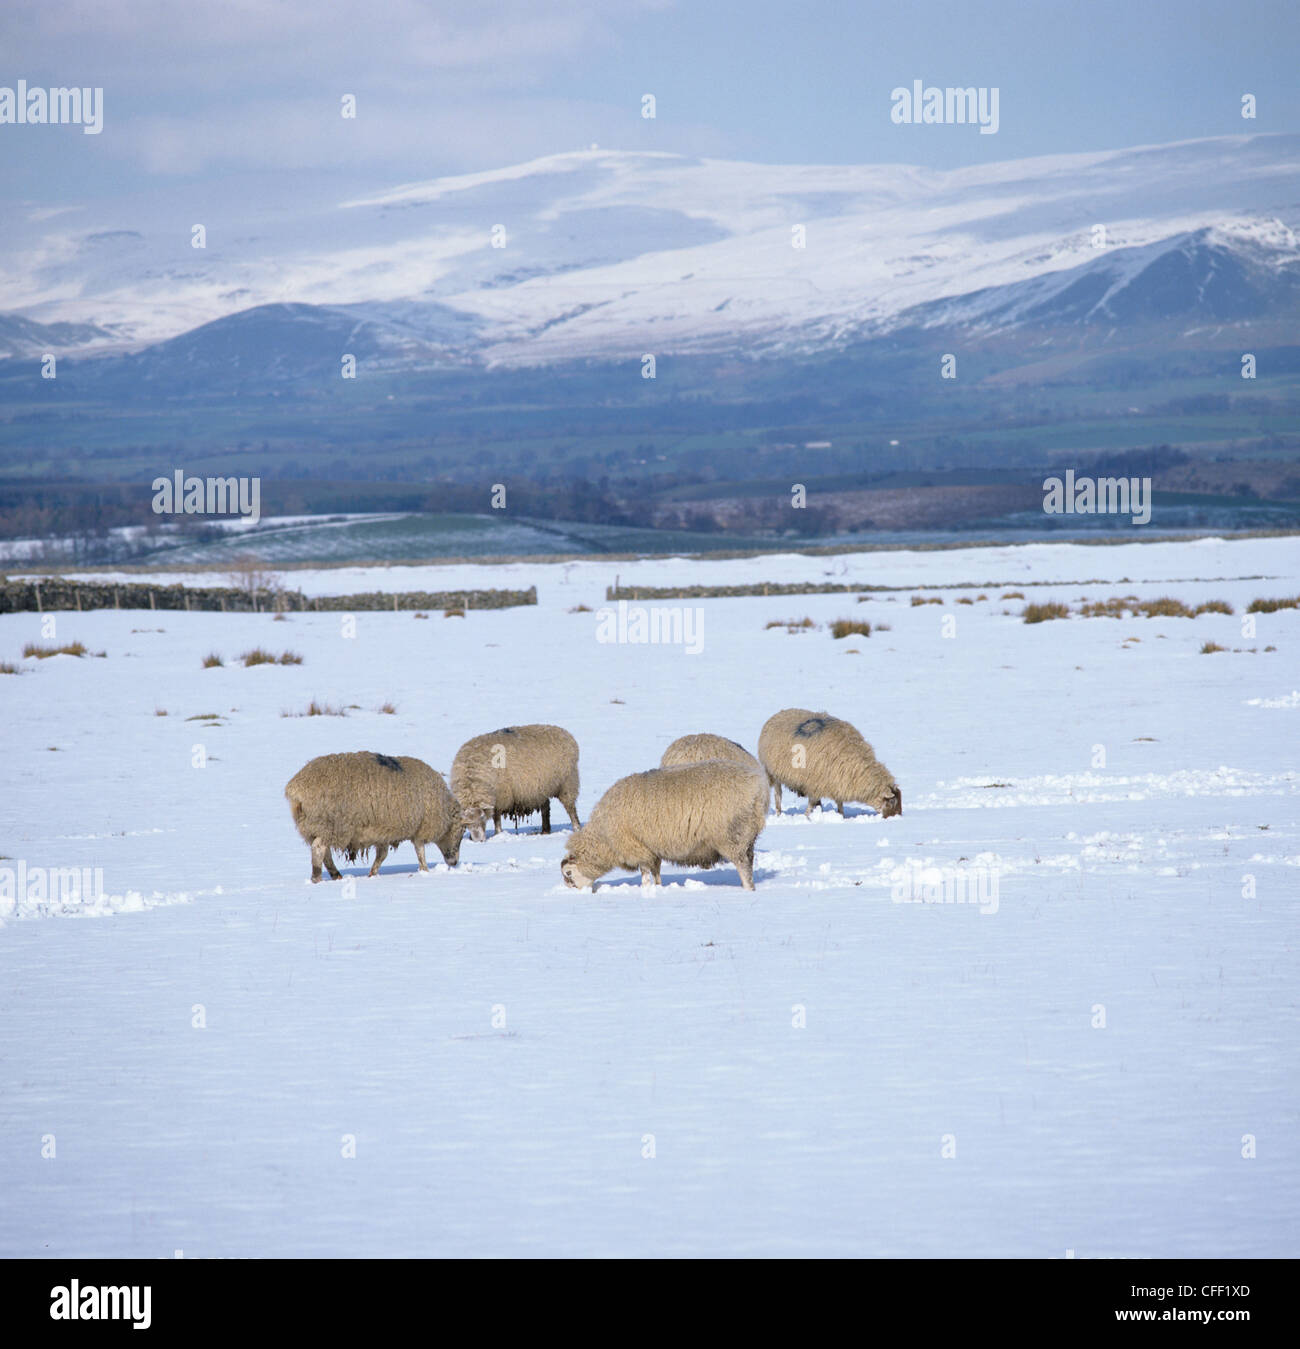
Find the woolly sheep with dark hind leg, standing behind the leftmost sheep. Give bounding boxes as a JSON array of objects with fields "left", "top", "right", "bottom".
[{"left": 452, "top": 726, "right": 580, "bottom": 843}]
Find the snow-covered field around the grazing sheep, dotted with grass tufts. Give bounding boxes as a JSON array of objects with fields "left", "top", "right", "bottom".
[{"left": 0, "top": 538, "right": 1300, "bottom": 1256}]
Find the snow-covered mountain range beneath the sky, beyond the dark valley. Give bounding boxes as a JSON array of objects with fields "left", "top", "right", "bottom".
[{"left": 0, "top": 135, "right": 1300, "bottom": 375}]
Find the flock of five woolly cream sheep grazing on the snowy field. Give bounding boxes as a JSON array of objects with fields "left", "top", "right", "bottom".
[{"left": 285, "top": 707, "right": 902, "bottom": 890}]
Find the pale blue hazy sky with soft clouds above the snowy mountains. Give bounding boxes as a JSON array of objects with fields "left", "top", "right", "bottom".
[{"left": 0, "top": 0, "right": 1300, "bottom": 205}]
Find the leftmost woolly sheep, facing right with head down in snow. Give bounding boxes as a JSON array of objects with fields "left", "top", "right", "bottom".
[{"left": 285, "top": 751, "right": 465, "bottom": 881}]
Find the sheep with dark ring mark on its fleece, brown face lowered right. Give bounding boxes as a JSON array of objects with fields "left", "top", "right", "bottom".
[{"left": 758, "top": 707, "right": 902, "bottom": 819}]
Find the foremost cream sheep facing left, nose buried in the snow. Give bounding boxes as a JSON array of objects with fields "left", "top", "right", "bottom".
[{"left": 560, "top": 759, "right": 767, "bottom": 890}]
